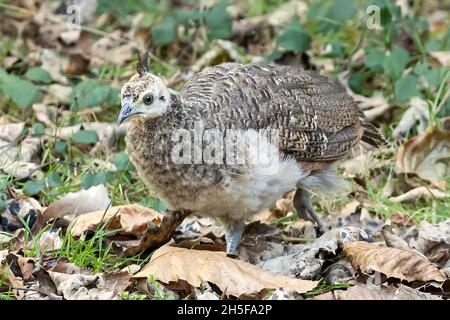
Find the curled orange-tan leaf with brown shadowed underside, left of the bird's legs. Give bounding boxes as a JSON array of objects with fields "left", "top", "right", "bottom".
[{"left": 71, "top": 204, "right": 163, "bottom": 237}]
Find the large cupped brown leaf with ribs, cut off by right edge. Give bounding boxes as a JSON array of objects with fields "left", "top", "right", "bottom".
[{"left": 396, "top": 129, "right": 450, "bottom": 189}]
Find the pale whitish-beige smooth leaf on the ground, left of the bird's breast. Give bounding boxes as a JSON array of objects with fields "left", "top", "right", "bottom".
[{"left": 43, "top": 184, "right": 111, "bottom": 220}]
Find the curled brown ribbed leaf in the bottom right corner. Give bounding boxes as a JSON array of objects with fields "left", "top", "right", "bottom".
[{"left": 344, "top": 242, "right": 446, "bottom": 282}]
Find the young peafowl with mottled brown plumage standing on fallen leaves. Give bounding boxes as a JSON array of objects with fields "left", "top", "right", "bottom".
[{"left": 119, "top": 58, "right": 383, "bottom": 253}]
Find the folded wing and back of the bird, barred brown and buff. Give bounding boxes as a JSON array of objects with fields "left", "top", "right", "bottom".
[{"left": 180, "top": 63, "right": 363, "bottom": 161}]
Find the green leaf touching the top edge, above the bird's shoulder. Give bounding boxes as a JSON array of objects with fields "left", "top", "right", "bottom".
[{"left": 204, "top": 0, "right": 232, "bottom": 40}]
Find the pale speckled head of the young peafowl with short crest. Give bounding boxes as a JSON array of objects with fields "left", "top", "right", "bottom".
[{"left": 117, "top": 51, "right": 170, "bottom": 125}]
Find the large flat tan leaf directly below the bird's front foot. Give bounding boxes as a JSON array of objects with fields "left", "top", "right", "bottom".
[{"left": 133, "top": 246, "right": 318, "bottom": 297}]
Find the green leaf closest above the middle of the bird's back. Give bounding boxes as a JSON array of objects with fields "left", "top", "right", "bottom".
[{"left": 278, "top": 19, "right": 311, "bottom": 52}]
